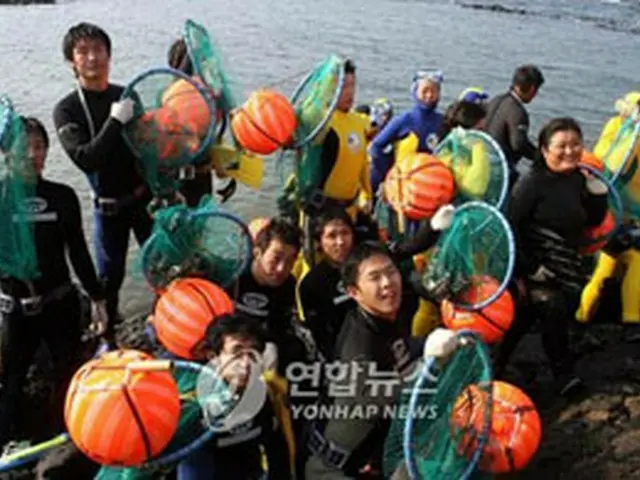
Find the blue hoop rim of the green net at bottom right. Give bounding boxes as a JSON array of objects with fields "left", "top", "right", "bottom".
[{"left": 402, "top": 330, "right": 493, "bottom": 480}]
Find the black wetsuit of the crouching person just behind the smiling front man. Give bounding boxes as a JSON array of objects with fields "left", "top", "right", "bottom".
[{"left": 298, "top": 261, "right": 355, "bottom": 360}]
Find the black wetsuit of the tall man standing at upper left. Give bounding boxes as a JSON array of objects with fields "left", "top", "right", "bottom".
[{"left": 53, "top": 85, "right": 153, "bottom": 338}]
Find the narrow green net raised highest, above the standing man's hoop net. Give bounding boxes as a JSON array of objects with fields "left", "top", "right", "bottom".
[{"left": 184, "top": 20, "right": 236, "bottom": 115}]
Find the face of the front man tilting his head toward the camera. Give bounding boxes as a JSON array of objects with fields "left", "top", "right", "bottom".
[{"left": 347, "top": 255, "right": 402, "bottom": 320}]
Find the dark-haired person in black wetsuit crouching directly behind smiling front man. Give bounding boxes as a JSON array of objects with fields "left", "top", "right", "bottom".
[{"left": 298, "top": 208, "right": 355, "bottom": 360}]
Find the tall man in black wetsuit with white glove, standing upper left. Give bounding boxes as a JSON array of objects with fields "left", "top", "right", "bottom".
[{"left": 53, "top": 23, "right": 153, "bottom": 343}]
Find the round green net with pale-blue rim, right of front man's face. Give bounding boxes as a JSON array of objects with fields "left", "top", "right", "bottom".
[{"left": 422, "top": 202, "right": 515, "bottom": 309}]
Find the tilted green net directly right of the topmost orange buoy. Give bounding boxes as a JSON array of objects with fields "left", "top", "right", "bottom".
[{"left": 289, "top": 55, "right": 345, "bottom": 148}]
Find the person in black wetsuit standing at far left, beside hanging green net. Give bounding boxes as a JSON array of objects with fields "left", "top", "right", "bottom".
[{"left": 0, "top": 118, "right": 106, "bottom": 446}]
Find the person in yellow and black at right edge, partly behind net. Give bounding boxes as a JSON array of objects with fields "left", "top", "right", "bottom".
[{"left": 576, "top": 92, "right": 640, "bottom": 342}]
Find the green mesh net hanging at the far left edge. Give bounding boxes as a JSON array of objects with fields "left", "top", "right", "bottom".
[{"left": 0, "top": 96, "right": 39, "bottom": 280}]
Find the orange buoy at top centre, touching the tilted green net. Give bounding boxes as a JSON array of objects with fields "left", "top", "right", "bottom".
[{"left": 231, "top": 89, "right": 297, "bottom": 155}]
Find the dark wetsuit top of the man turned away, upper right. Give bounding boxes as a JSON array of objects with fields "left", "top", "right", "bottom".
[{"left": 484, "top": 92, "right": 536, "bottom": 186}]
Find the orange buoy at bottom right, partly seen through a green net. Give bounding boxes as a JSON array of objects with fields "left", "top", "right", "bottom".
[{"left": 450, "top": 381, "right": 542, "bottom": 474}]
